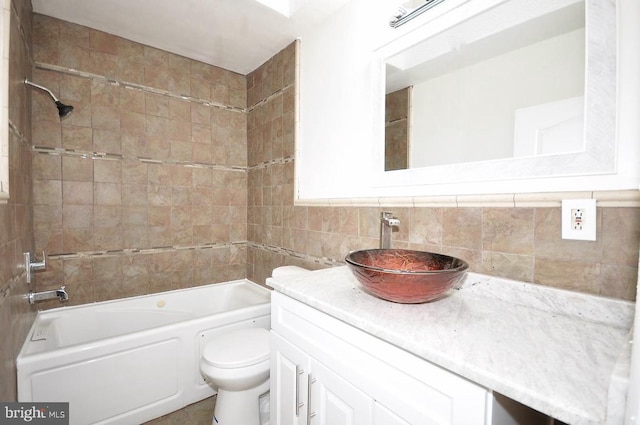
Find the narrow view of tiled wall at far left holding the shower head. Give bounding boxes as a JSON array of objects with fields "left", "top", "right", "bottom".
[{"left": 0, "top": 0, "right": 35, "bottom": 401}]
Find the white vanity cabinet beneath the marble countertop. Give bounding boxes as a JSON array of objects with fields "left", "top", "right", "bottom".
[{"left": 271, "top": 292, "right": 492, "bottom": 425}]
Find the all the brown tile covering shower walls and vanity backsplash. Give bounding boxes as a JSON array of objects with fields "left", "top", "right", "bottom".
[{"left": 0, "top": 0, "right": 640, "bottom": 400}]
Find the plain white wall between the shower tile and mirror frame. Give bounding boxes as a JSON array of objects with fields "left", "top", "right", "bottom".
[{"left": 296, "top": 0, "right": 395, "bottom": 198}]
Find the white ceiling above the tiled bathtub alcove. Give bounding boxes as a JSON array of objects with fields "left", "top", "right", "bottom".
[{"left": 32, "top": 0, "right": 350, "bottom": 75}]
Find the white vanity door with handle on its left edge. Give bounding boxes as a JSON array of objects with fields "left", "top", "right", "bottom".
[{"left": 308, "top": 360, "right": 373, "bottom": 425}]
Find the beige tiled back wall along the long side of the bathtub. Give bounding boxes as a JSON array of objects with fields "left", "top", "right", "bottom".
[{"left": 32, "top": 14, "right": 247, "bottom": 307}]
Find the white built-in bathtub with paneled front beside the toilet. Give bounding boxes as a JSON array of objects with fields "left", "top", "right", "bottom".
[{"left": 16, "top": 280, "right": 271, "bottom": 425}]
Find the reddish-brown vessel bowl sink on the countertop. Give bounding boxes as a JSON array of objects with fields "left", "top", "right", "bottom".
[{"left": 345, "top": 249, "right": 469, "bottom": 304}]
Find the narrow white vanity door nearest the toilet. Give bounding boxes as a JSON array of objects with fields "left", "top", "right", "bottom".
[{"left": 270, "top": 331, "right": 309, "bottom": 425}]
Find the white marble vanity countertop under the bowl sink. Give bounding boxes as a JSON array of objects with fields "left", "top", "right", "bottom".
[{"left": 267, "top": 266, "right": 635, "bottom": 425}]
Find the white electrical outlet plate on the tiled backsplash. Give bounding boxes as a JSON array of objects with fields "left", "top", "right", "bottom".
[{"left": 562, "top": 199, "right": 597, "bottom": 241}]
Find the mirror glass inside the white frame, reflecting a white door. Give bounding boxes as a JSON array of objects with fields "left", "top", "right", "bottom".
[{"left": 385, "top": 1, "right": 585, "bottom": 171}]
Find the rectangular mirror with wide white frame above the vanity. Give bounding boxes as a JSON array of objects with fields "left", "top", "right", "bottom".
[{"left": 374, "top": 0, "right": 633, "bottom": 196}]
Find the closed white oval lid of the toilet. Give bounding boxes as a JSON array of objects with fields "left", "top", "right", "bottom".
[{"left": 202, "top": 328, "right": 269, "bottom": 369}]
